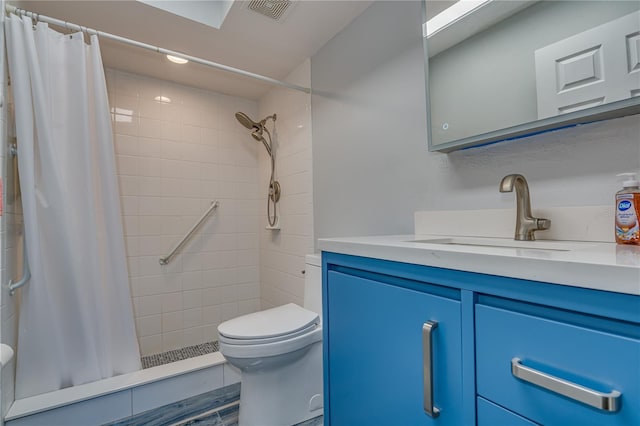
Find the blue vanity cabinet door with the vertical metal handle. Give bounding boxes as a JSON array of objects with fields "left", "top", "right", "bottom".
[{"left": 324, "top": 270, "right": 463, "bottom": 426}]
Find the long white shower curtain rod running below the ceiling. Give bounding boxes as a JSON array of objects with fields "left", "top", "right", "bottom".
[{"left": 5, "top": 4, "right": 311, "bottom": 93}]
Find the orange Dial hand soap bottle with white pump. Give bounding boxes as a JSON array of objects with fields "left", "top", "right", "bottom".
[{"left": 616, "top": 173, "right": 640, "bottom": 245}]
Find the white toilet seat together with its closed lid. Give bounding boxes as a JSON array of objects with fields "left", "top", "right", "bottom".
[{"left": 218, "top": 303, "right": 322, "bottom": 358}]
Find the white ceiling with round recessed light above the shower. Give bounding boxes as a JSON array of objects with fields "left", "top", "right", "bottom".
[{"left": 10, "top": 0, "right": 373, "bottom": 99}]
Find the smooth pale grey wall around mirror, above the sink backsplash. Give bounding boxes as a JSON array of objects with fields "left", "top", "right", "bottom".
[{"left": 311, "top": 1, "right": 640, "bottom": 238}]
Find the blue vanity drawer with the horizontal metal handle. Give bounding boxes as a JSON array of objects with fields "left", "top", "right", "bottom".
[{"left": 476, "top": 305, "right": 640, "bottom": 426}]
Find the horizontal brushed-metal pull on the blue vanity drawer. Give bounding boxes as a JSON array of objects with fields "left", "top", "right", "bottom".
[{"left": 511, "top": 358, "right": 622, "bottom": 412}]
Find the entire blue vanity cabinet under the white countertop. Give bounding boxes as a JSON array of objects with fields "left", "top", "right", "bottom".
[{"left": 323, "top": 252, "right": 640, "bottom": 426}]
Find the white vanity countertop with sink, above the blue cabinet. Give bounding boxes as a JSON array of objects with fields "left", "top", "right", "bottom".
[{"left": 318, "top": 235, "right": 640, "bottom": 295}]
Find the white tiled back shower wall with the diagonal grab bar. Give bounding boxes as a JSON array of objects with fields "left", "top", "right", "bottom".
[{"left": 106, "top": 70, "right": 262, "bottom": 355}]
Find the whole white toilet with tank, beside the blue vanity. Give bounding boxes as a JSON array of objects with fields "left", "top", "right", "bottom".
[{"left": 218, "top": 255, "right": 323, "bottom": 426}]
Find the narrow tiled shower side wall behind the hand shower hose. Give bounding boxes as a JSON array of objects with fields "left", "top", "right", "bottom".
[{"left": 256, "top": 60, "right": 314, "bottom": 309}]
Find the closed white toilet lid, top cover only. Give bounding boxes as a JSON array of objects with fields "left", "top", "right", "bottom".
[{"left": 218, "top": 303, "right": 320, "bottom": 340}]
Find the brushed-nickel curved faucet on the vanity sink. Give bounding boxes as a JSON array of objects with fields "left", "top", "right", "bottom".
[{"left": 500, "top": 174, "right": 551, "bottom": 241}]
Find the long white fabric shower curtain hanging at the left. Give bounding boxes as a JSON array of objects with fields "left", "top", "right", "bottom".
[{"left": 6, "top": 15, "right": 140, "bottom": 398}]
